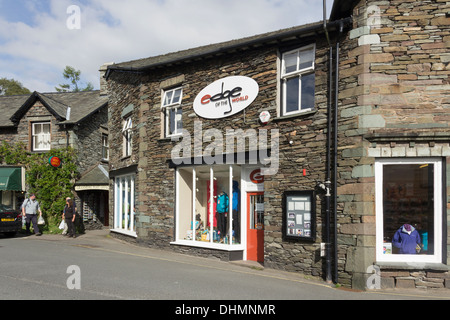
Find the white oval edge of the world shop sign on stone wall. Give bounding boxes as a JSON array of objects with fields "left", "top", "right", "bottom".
[{"left": 194, "top": 76, "right": 259, "bottom": 119}]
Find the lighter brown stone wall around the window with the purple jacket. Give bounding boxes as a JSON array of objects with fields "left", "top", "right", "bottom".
[{"left": 338, "top": 0, "right": 450, "bottom": 288}]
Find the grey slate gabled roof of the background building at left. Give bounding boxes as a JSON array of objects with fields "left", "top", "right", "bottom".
[{"left": 0, "top": 90, "right": 108, "bottom": 127}]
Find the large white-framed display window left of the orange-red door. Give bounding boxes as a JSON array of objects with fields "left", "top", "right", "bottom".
[{"left": 176, "top": 165, "right": 242, "bottom": 249}]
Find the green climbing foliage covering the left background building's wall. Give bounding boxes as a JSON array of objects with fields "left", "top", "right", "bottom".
[{"left": 0, "top": 141, "right": 79, "bottom": 230}]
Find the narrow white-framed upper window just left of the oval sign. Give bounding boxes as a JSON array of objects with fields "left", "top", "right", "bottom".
[{"left": 162, "top": 87, "right": 183, "bottom": 137}]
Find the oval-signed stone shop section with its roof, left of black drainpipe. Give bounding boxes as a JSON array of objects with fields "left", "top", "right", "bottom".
[{"left": 107, "top": 23, "right": 344, "bottom": 276}]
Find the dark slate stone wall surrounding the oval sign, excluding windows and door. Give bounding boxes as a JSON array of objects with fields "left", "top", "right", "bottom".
[{"left": 108, "top": 38, "right": 328, "bottom": 276}]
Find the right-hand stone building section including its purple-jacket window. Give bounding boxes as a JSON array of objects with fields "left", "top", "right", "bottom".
[{"left": 332, "top": 0, "right": 450, "bottom": 288}]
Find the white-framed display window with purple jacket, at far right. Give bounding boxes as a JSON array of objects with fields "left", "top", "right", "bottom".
[{"left": 375, "top": 159, "right": 443, "bottom": 263}]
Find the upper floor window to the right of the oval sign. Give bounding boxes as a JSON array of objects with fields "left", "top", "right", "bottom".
[{"left": 281, "top": 45, "right": 316, "bottom": 116}]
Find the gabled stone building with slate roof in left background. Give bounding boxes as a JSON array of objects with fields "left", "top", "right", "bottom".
[{"left": 0, "top": 91, "right": 108, "bottom": 227}]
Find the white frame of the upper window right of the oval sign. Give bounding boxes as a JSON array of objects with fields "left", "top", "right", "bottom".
[{"left": 281, "top": 44, "right": 316, "bottom": 116}]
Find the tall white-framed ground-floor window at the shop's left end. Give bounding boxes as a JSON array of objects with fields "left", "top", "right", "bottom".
[{"left": 112, "top": 174, "right": 137, "bottom": 237}]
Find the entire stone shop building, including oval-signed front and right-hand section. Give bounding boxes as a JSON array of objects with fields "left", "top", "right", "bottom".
[{"left": 106, "top": 0, "right": 450, "bottom": 289}]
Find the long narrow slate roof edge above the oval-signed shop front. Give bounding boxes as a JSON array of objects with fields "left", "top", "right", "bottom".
[{"left": 106, "top": 21, "right": 334, "bottom": 77}]
